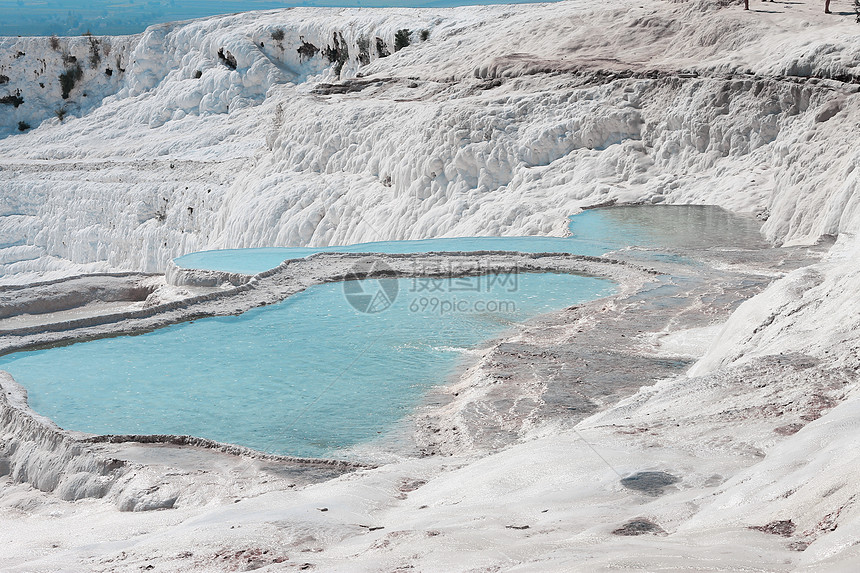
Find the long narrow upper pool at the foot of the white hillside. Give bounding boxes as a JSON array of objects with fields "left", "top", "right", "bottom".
[{"left": 174, "top": 205, "right": 767, "bottom": 274}]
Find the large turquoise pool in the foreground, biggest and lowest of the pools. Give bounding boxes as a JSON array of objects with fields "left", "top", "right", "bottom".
[{"left": 0, "top": 274, "right": 614, "bottom": 456}]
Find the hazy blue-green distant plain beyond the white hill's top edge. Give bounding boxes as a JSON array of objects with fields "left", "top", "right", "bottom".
[{"left": 0, "top": 0, "right": 552, "bottom": 36}]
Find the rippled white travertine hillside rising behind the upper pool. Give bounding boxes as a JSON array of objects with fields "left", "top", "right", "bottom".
[{"left": 0, "top": 2, "right": 860, "bottom": 282}]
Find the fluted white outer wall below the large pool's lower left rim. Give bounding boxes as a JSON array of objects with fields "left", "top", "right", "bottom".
[{"left": 0, "top": 371, "right": 377, "bottom": 511}]
